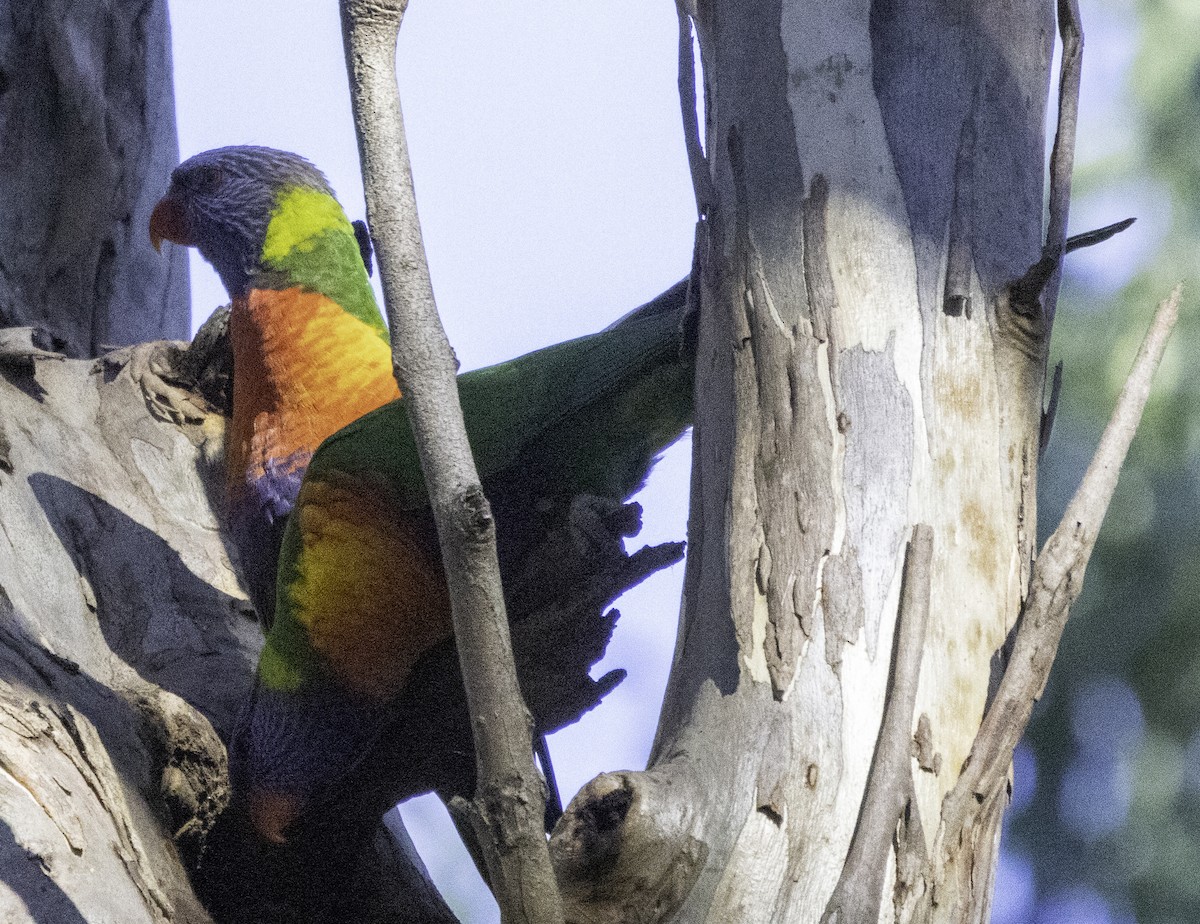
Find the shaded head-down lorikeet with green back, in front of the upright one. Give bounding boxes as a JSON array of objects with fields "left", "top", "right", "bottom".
[{"left": 230, "top": 304, "right": 691, "bottom": 841}]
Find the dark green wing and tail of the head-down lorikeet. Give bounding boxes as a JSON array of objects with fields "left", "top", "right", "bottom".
[{"left": 308, "top": 314, "right": 694, "bottom": 510}]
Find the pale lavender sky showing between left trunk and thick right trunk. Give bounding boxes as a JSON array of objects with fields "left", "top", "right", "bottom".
[{"left": 170, "top": 0, "right": 695, "bottom": 922}]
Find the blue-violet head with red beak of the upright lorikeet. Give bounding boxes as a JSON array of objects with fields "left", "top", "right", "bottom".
[{"left": 150, "top": 145, "right": 334, "bottom": 298}]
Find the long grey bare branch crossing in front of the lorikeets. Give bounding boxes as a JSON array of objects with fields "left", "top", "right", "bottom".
[{"left": 341, "top": 0, "right": 563, "bottom": 923}]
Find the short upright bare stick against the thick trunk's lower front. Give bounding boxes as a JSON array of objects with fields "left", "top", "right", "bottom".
[{"left": 821, "top": 523, "right": 934, "bottom": 924}]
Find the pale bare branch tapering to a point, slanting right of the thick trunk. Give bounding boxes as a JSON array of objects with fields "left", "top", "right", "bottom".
[{"left": 935, "top": 287, "right": 1180, "bottom": 840}]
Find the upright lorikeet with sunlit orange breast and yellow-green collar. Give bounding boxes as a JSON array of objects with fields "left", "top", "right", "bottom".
[{"left": 150, "top": 146, "right": 400, "bottom": 625}]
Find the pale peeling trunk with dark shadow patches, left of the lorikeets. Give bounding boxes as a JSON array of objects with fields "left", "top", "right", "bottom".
[{"left": 0, "top": 330, "right": 241, "bottom": 924}]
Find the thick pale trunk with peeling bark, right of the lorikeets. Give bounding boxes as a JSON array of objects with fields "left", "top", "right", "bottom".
[{"left": 554, "top": 0, "right": 1054, "bottom": 922}]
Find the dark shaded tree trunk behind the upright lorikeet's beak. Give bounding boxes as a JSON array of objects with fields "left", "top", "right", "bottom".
[{"left": 0, "top": 0, "right": 190, "bottom": 356}]
